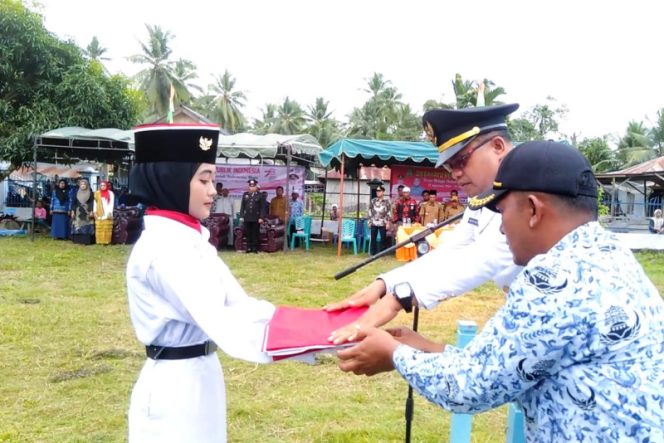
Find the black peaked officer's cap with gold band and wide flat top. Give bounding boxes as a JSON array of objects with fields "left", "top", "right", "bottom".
[{"left": 422, "top": 103, "right": 519, "bottom": 167}]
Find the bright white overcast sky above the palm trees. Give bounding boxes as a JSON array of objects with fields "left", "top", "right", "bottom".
[{"left": 39, "top": 0, "right": 664, "bottom": 142}]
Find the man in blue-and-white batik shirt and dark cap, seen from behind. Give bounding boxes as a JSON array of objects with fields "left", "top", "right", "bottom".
[{"left": 339, "top": 141, "right": 664, "bottom": 442}]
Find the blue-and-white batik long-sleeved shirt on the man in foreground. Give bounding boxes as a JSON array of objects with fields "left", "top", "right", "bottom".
[{"left": 393, "top": 222, "right": 664, "bottom": 443}]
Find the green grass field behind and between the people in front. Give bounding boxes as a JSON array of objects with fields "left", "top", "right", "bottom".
[{"left": 0, "top": 237, "right": 664, "bottom": 443}]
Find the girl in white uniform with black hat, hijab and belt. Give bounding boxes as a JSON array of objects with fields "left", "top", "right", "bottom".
[{"left": 127, "top": 125, "right": 274, "bottom": 443}]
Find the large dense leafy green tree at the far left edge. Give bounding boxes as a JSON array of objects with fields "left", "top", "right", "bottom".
[{"left": 0, "top": 0, "right": 140, "bottom": 172}]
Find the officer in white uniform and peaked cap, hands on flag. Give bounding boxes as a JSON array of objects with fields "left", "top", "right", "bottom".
[{"left": 326, "top": 104, "right": 521, "bottom": 344}]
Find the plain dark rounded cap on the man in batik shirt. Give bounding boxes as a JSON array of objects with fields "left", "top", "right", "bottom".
[{"left": 468, "top": 141, "right": 597, "bottom": 211}]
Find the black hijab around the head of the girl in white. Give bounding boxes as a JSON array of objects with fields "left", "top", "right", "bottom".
[{"left": 129, "top": 162, "right": 200, "bottom": 214}]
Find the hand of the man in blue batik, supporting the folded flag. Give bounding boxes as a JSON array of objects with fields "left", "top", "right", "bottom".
[{"left": 337, "top": 328, "right": 399, "bottom": 376}]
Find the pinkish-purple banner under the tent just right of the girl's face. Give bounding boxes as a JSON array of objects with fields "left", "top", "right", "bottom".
[{"left": 215, "top": 163, "right": 305, "bottom": 199}]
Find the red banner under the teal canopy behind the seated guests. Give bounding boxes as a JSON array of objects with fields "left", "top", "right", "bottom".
[{"left": 390, "top": 165, "right": 467, "bottom": 203}]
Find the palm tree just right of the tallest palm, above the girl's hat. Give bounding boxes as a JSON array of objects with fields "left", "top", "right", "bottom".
[{"left": 208, "top": 69, "right": 247, "bottom": 133}]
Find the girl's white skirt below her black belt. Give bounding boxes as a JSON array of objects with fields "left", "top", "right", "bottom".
[{"left": 129, "top": 353, "right": 226, "bottom": 443}]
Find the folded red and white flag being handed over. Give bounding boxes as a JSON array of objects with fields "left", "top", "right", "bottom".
[{"left": 263, "top": 306, "right": 369, "bottom": 360}]
